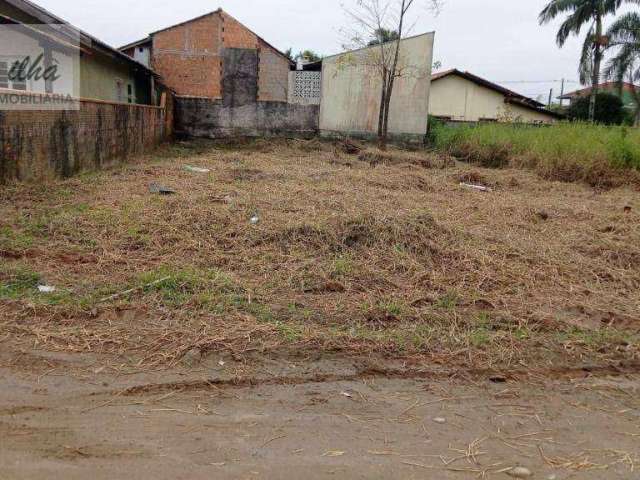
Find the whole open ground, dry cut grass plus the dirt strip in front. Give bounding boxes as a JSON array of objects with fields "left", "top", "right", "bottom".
[{"left": 0, "top": 140, "right": 640, "bottom": 479}]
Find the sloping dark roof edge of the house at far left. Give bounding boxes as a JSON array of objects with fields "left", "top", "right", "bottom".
[{"left": 5, "top": 0, "right": 157, "bottom": 76}]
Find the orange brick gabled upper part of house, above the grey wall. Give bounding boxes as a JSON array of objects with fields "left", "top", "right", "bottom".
[{"left": 120, "top": 9, "right": 294, "bottom": 106}]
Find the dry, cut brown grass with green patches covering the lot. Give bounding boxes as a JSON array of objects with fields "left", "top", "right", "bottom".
[{"left": 0, "top": 140, "right": 640, "bottom": 368}]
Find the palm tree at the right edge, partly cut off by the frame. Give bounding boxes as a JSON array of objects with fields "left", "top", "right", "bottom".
[{"left": 605, "top": 12, "right": 640, "bottom": 126}]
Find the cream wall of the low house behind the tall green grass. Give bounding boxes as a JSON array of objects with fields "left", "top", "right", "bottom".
[{"left": 429, "top": 75, "right": 555, "bottom": 123}]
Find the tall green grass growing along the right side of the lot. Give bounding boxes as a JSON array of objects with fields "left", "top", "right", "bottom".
[{"left": 431, "top": 122, "right": 640, "bottom": 187}]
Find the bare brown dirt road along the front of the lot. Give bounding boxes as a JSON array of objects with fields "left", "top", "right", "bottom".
[{"left": 0, "top": 351, "right": 640, "bottom": 480}]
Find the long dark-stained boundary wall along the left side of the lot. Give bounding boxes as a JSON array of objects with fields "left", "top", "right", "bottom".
[{"left": 0, "top": 96, "right": 173, "bottom": 184}]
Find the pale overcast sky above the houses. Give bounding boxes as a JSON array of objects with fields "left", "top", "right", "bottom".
[{"left": 34, "top": 0, "right": 636, "bottom": 101}]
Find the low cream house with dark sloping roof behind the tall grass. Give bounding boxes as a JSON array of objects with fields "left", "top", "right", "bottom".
[{"left": 429, "top": 70, "right": 562, "bottom": 123}]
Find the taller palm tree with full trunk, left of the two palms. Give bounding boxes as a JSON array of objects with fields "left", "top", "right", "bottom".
[{"left": 539, "top": 0, "right": 640, "bottom": 121}]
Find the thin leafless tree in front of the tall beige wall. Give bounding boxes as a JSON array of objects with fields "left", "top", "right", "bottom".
[{"left": 343, "top": 0, "right": 443, "bottom": 150}]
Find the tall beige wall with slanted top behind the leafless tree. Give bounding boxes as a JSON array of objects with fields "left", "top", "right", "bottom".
[{"left": 320, "top": 33, "right": 434, "bottom": 136}]
